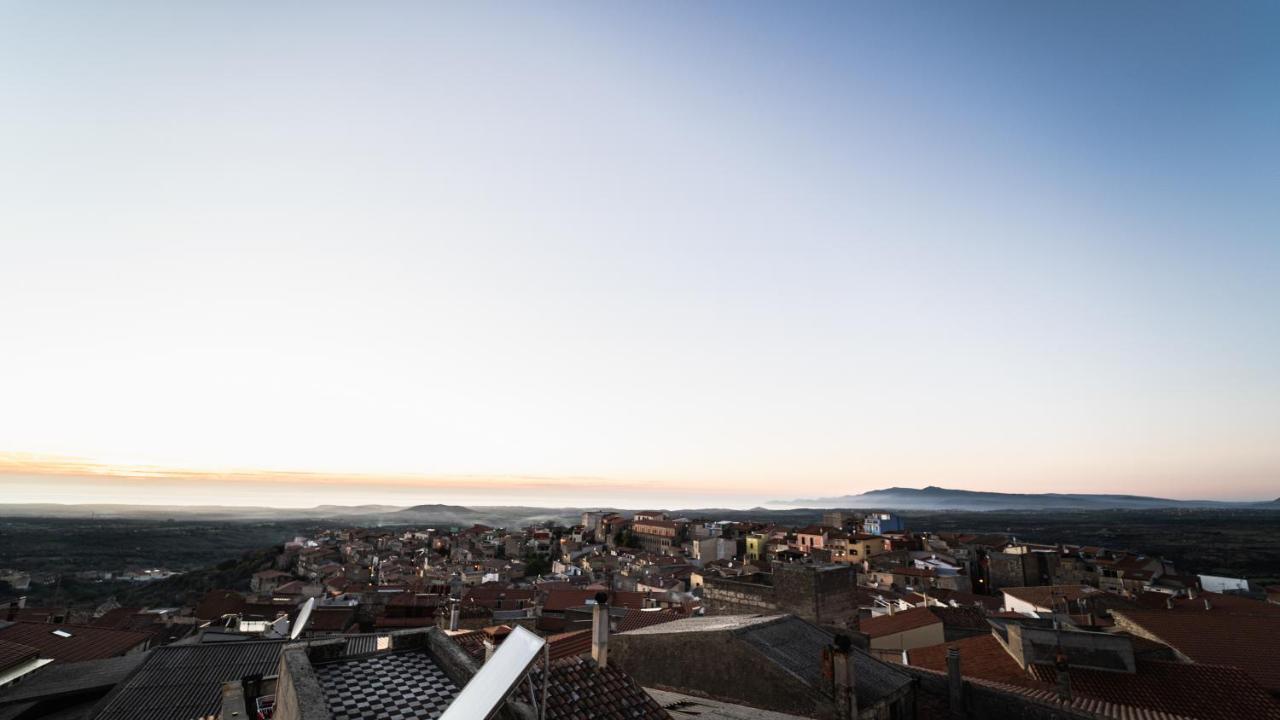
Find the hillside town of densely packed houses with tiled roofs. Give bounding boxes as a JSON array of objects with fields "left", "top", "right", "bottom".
[{"left": 0, "top": 510, "right": 1280, "bottom": 720}]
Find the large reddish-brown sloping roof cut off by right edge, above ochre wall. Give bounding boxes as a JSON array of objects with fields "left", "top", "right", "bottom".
[{"left": 1112, "top": 610, "right": 1280, "bottom": 692}]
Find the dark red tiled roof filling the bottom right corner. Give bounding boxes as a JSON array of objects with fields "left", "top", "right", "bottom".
[{"left": 1029, "top": 661, "right": 1280, "bottom": 720}]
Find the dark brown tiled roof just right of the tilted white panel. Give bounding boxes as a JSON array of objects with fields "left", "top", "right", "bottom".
[{"left": 530, "top": 656, "right": 671, "bottom": 720}]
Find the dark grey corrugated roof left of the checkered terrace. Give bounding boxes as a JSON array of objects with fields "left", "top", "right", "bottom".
[{"left": 91, "top": 641, "right": 284, "bottom": 720}]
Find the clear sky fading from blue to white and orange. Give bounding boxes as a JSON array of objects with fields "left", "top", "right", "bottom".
[{"left": 0, "top": 0, "right": 1280, "bottom": 507}]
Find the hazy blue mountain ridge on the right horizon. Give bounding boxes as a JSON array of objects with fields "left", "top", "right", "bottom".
[{"left": 772, "top": 486, "right": 1280, "bottom": 511}]
